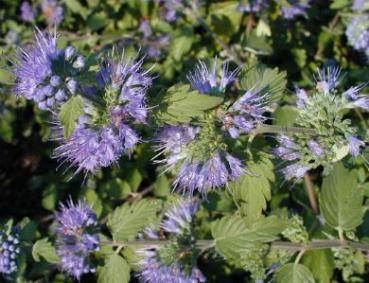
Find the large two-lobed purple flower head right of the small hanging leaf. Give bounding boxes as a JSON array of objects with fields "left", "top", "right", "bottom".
[{"left": 54, "top": 52, "right": 152, "bottom": 173}]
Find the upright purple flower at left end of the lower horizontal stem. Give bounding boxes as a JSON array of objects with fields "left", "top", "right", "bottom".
[{"left": 56, "top": 200, "right": 100, "bottom": 280}]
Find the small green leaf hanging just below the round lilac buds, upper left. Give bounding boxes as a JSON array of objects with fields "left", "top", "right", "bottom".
[{"left": 59, "top": 95, "right": 84, "bottom": 138}]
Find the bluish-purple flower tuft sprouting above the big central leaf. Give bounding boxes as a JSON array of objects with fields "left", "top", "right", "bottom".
[{"left": 187, "top": 58, "right": 239, "bottom": 94}]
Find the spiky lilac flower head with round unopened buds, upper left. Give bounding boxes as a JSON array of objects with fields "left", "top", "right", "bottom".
[{"left": 12, "top": 30, "right": 83, "bottom": 109}]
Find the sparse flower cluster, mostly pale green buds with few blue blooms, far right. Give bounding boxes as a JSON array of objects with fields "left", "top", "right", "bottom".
[{"left": 273, "top": 68, "right": 369, "bottom": 179}]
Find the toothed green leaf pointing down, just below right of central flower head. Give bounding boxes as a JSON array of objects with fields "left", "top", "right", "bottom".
[{"left": 230, "top": 158, "right": 275, "bottom": 222}]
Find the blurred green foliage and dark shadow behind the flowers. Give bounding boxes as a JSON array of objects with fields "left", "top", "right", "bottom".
[{"left": 0, "top": 0, "right": 369, "bottom": 282}]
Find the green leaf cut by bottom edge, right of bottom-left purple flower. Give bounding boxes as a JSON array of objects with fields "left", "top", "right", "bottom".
[{"left": 97, "top": 253, "right": 130, "bottom": 283}]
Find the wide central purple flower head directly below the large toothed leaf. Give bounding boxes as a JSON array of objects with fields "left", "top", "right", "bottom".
[{"left": 156, "top": 126, "right": 246, "bottom": 195}]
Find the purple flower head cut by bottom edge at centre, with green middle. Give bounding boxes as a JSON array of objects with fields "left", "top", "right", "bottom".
[{"left": 138, "top": 200, "right": 206, "bottom": 283}]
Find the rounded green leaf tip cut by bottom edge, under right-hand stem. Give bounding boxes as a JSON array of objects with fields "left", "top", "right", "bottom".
[{"left": 276, "top": 263, "right": 315, "bottom": 283}]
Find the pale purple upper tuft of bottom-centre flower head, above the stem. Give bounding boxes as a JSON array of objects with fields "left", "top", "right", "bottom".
[{"left": 161, "top": 201, "right": 199, "bottom": 234}]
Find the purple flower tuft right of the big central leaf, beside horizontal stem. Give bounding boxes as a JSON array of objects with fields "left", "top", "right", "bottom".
[{"left": 223, "top": 91, "right": 269, "bottom": 138}]
